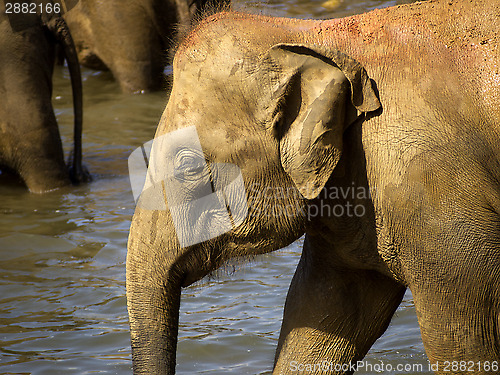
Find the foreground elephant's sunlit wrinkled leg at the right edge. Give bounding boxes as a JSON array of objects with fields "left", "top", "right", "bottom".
[{"left": 402, "top": 217, "right": 500, "bottom": 374}]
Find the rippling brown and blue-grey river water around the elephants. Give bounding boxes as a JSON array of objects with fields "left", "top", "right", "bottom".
[{"left": 0, "top": 0, "right": 429, "bottom": 375}]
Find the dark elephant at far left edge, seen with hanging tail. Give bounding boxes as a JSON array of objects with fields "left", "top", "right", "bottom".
[{"left": 0, "top": 2, "right": 89, "bottom": 193}]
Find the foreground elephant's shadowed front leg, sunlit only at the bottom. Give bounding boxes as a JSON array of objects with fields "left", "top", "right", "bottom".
[{"left": 273, "top": 237, "right": 406, "bottom": 374}]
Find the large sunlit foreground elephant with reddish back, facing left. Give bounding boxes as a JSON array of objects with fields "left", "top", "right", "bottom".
[{"left": 126, "top": 0, "right": 500, "bottom": 374}]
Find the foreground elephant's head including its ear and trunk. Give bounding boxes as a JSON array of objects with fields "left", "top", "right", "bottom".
[{"left": 127, "top": 11, "right": 380, "bottom": 374}]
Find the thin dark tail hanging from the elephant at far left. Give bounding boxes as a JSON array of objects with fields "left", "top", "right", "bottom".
[{"left": 47, "top": 17, "right": 89, "bottom": 184}]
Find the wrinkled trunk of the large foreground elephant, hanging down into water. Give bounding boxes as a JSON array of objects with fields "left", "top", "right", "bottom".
[{"left": 127, "top": 210, "right": 182, "bottom": 374}]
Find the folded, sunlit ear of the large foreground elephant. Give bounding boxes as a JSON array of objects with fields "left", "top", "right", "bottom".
[{"left": 268, "top": 44, "right": 381, "bottom": 199}]
